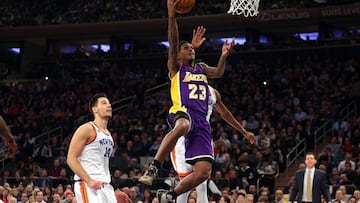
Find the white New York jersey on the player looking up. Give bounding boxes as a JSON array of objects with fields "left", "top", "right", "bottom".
[{"left": 74, "top": 122, "right": 114, "bottom": 183}]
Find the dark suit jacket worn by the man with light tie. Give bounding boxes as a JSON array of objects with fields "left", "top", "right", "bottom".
[{"left": 289, "top": 169, "right": 331, "bottom": 203}]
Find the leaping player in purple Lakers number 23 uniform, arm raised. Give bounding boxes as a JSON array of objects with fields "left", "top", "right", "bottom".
[{"left": 139, "top": 0, "right": 234, "bottom": 203}]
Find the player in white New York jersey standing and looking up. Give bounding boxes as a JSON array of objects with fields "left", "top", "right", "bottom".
[{"left": 67, "top": 93, "right": 131, "bottom": 203}]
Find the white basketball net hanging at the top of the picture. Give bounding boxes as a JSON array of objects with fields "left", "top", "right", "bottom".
[{"left": 228, "top": 0, "right": 260, "bottom": 17}]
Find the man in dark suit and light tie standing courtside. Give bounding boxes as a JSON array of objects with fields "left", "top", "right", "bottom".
[{"left": 289, "top": 152, "right": 331, "bottom": 203}]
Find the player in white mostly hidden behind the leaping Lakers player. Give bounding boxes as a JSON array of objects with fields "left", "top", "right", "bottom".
[{"left": 170, "top": 85, "right": 255, "bottom": 203}]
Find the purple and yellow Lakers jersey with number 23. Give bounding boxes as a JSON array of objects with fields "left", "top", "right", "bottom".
[{"left": 169, "top": 64, "right": 209, "bottom": 115}]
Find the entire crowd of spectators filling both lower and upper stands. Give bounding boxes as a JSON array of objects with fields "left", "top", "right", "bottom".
[{"left": 0, "top": 0, "right": 360, "bottom": 203}]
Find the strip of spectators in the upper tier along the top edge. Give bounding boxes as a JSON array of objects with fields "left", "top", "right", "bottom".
[{"left": 0, "top": 0, "right": 356, "bottom": 26}]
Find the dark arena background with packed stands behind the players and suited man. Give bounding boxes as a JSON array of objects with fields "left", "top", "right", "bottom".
[{"left": 0, "top": 0, "right": 360, "bottom": 203}]
